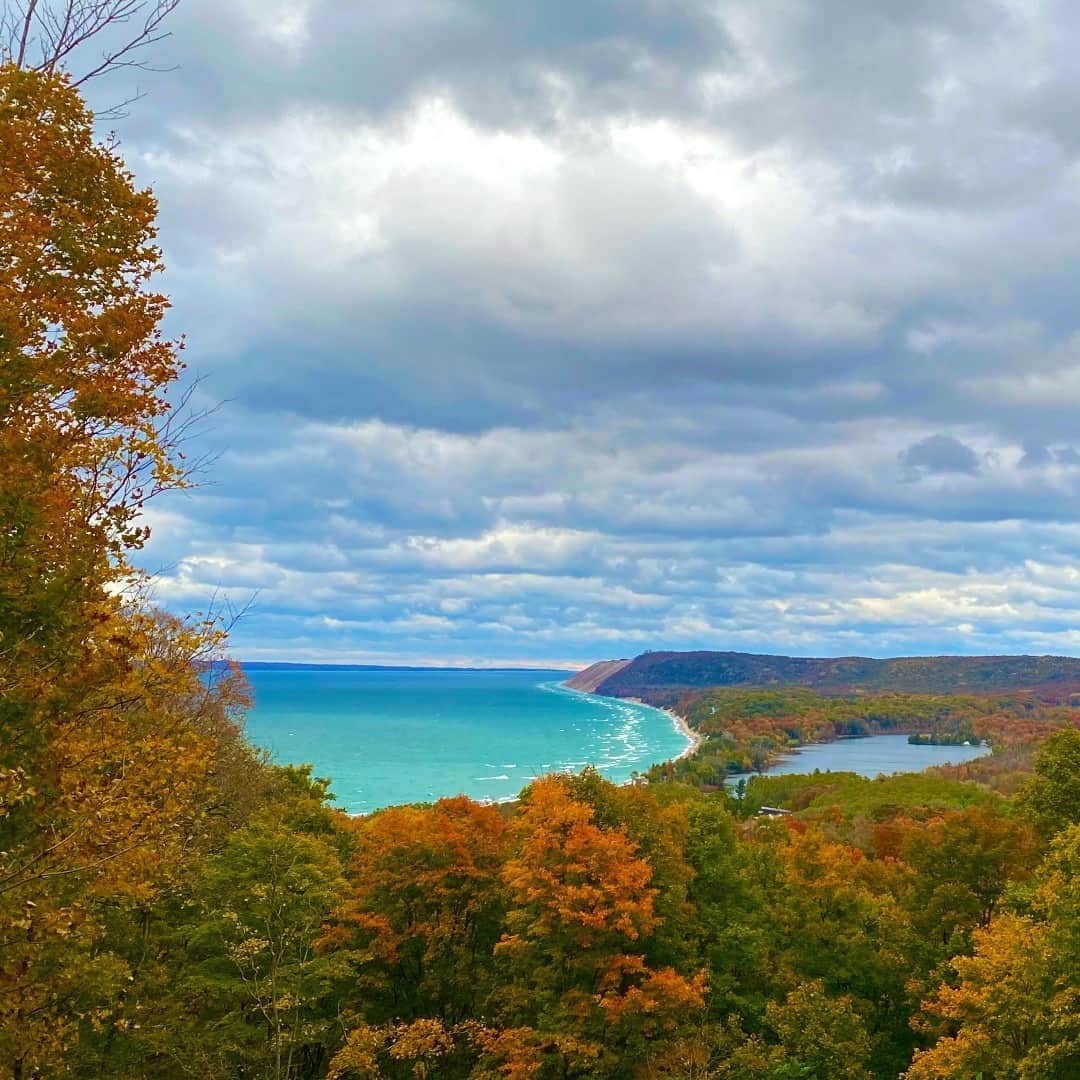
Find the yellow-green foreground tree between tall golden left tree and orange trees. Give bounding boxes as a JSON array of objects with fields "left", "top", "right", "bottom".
[{"left": 123, "top": 800, "right": 347, "bottom": 1080}]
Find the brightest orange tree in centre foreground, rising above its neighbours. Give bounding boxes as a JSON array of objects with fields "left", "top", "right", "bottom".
[{"left": 486, "top": 777, "right": 705, "bottom": 1076}]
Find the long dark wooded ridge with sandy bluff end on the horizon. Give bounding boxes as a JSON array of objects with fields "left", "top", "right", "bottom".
[{"left": 567, "top": 652, "right": 1080, "bottom": 704}]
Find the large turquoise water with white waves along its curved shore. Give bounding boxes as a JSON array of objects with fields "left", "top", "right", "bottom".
[{"left": 240, "top": 669, "right": 686, "bottom": 813}]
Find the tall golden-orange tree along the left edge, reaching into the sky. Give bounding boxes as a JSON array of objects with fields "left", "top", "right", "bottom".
[{"left": 0, "top": 65, "right": 243, "bottom": 1076}]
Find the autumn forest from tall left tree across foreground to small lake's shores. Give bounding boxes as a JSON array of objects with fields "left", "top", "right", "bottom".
[{"left": 0, "top": 64, "right": 1080, "bottom": 1080}]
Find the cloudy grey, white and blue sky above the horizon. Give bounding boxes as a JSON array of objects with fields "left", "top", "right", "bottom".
[{"left": 71, "top": 0, "right": 1080, "bottom": 665}]
